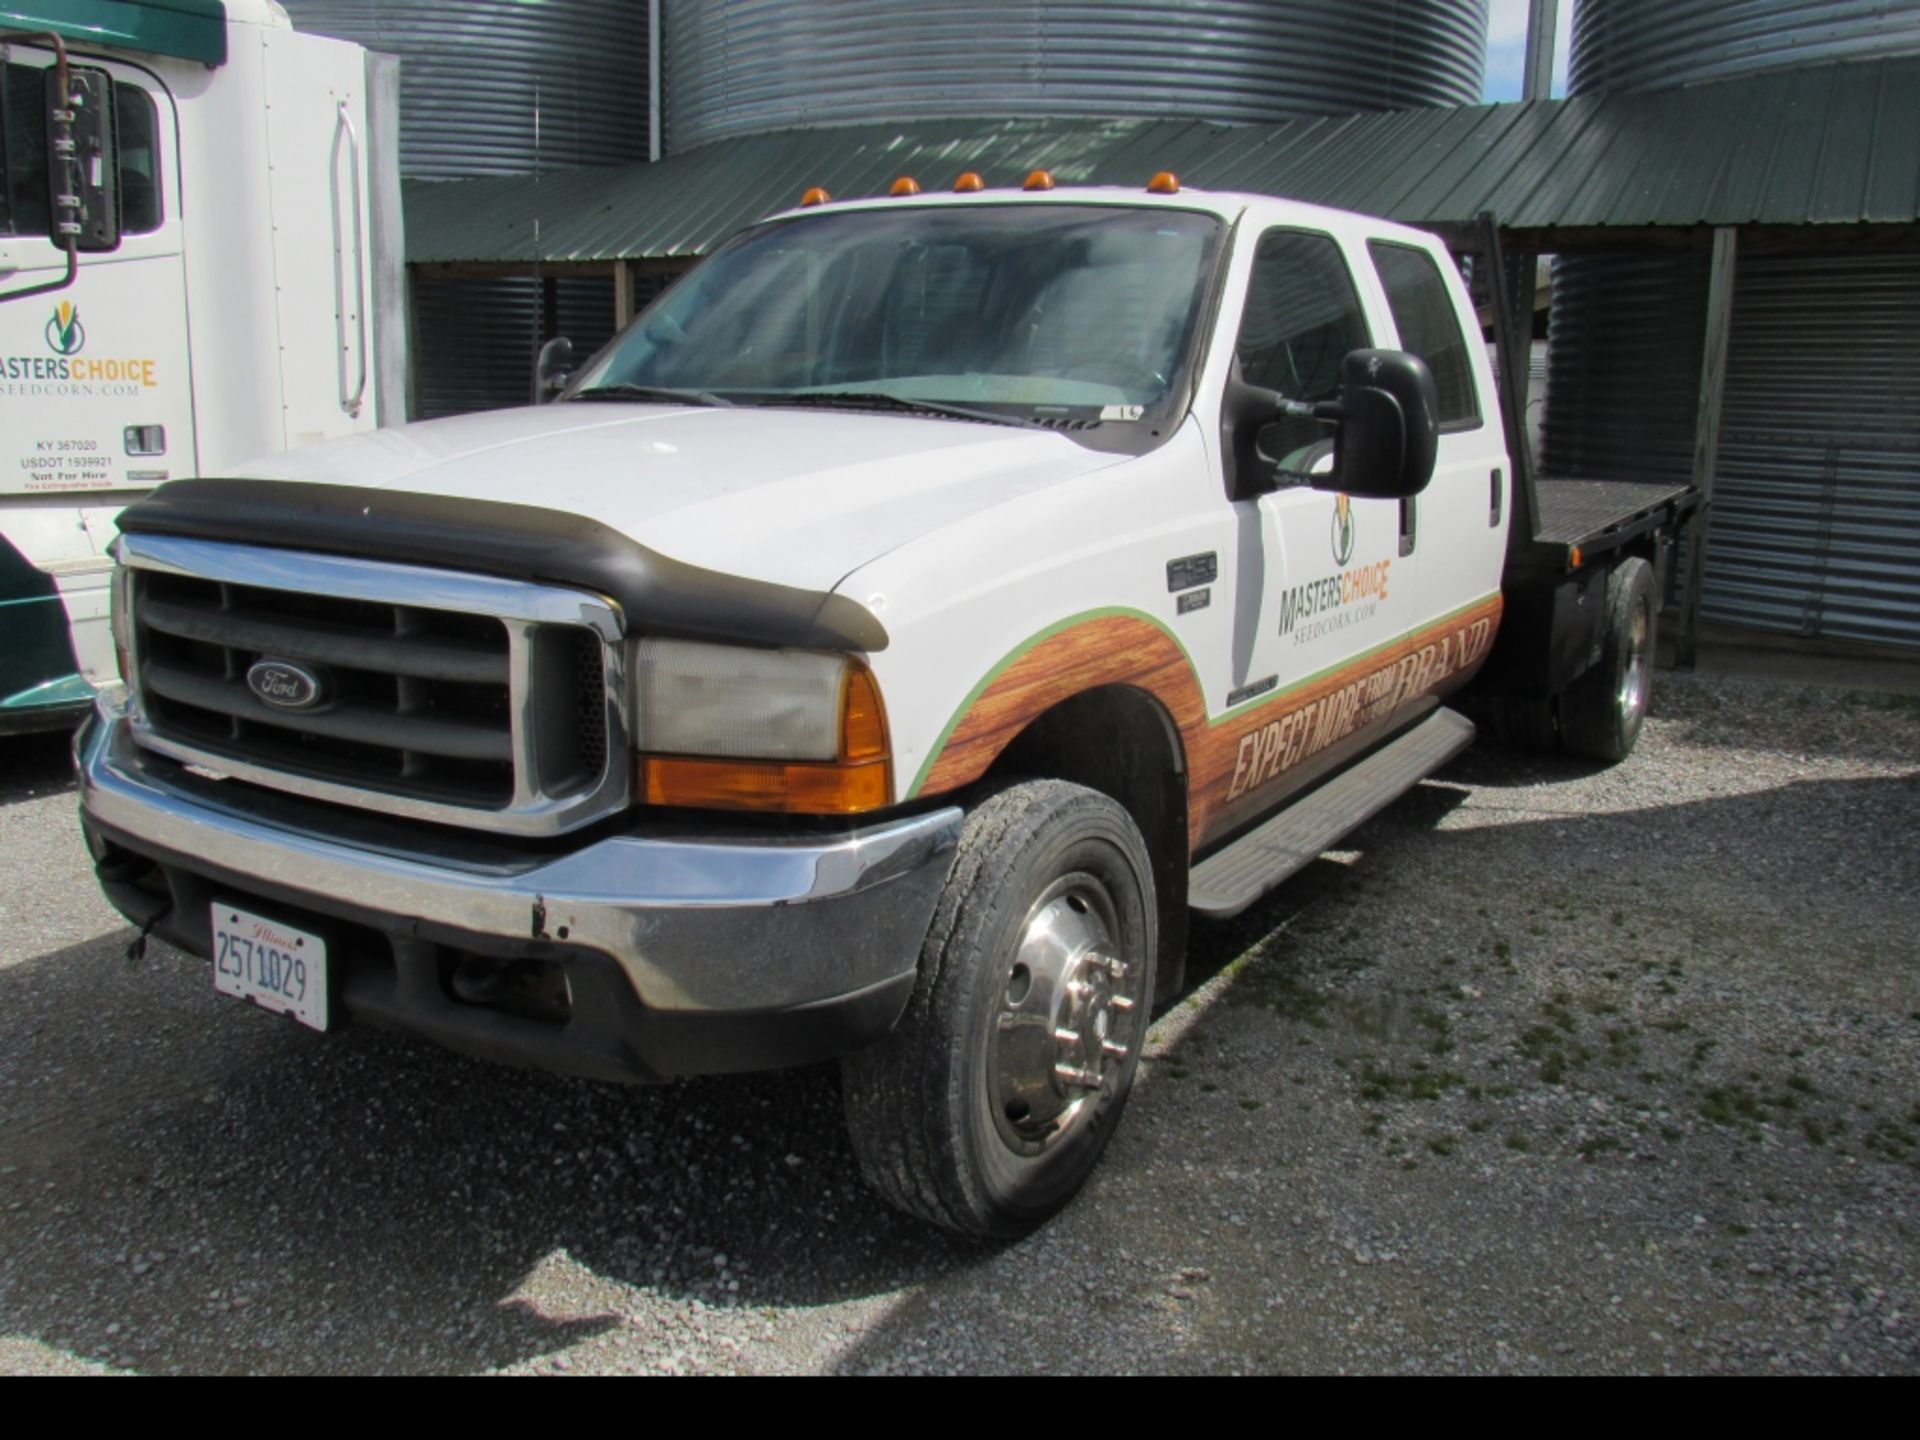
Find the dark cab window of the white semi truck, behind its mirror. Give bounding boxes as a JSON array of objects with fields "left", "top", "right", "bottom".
[{"left": 0, "top": 65, "right": 165, "bottom": 234}]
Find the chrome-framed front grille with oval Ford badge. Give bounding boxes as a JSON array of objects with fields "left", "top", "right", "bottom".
[{"left": 121, "top": 534, "right": 628, "bottom": 833}]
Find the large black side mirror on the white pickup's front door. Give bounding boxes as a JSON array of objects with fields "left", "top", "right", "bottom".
[{"left": 1313, "top": 349, "right": 1440, "bottom": 499}]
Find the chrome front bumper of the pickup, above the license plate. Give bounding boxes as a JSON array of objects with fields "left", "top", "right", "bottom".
[{"left": 75, "top": 695, "right": 962, "bottom": 1077}]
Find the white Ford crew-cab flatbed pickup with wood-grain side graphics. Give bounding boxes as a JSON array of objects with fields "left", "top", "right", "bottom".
[{"left": 77, "top": 175, "right": 1692, "bottom": 1235}]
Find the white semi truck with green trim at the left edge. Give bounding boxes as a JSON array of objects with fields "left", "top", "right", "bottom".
[{"left": 0, "top": 0, "right": 405, "bottom": 733}]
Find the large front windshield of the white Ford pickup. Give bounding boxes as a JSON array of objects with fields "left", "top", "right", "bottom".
[{"left": 570, "top": 204, "right": 1221, "bottom": 422}]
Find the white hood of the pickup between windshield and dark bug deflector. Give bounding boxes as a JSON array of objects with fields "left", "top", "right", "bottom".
[{"left": 230, "top": 403, "right": 1125, "bottom": 589}]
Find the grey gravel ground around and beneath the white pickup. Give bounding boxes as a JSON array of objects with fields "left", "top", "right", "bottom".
[{"left": 0, "top": 674, "right": 1920, "bottom": 1373}]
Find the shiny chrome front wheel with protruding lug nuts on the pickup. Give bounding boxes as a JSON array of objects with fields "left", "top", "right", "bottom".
[{"left": 987, "top": 876, "right": 1144, "bottom": 1156}]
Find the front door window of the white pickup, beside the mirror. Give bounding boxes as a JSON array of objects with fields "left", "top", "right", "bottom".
[{"left": 1235, "top": 230, "right": 1373, "bottom": 470}]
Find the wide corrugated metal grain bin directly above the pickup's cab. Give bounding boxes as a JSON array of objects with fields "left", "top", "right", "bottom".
[{"left": 662, "top": 0, "right": 1486, "bottom": 150}]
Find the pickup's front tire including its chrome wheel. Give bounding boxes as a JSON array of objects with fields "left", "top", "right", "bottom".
[{"left": 841, "top": 780, "right": 1158, "bottom": 1236}]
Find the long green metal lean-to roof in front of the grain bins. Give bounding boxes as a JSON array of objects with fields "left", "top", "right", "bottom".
[{"left": 407, "top": 60, "right": 1920, "bottom": 263}]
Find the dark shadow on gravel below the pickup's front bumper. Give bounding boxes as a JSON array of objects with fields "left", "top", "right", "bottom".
[{"left": 0, "top": 931, "right": 977, "bottom": 1373}]
